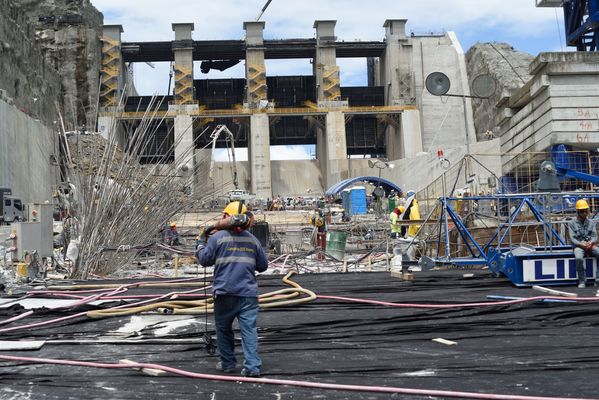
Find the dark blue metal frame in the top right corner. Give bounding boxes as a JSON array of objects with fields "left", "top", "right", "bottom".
[{"left": 563, "top": 0, "right": 599, "bottom": 51}]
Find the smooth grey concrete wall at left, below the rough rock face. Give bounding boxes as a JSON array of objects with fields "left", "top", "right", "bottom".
[{"left": 0, "top": 100, "right": 58, "bottom": 203}]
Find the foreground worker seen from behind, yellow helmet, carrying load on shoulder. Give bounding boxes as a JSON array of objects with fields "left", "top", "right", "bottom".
[{"left": 196, "top": 201, "right": 268, "bottom": 376}]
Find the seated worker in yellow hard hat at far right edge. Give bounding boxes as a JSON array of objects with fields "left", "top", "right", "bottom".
[{"left": 568, "top": 199, "right": 599, "bottom": 288}]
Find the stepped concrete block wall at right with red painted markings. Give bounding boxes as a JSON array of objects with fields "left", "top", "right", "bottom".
[{"left": 497, "top": 52, "right": 599, "bottom": 172}]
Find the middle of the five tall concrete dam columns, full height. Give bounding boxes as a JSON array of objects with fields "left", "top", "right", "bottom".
[{"left": 243, "top": 21, "right": 272, "bottom": 199}]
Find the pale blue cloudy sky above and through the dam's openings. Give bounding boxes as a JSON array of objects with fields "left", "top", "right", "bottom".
[{"left": 92, "top": 0, "right": 567, "bottom": 159}]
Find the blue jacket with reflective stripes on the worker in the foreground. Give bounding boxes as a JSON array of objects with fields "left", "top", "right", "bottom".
[{"left": 197, "top": 231, "right": 268, "bottom": 297}]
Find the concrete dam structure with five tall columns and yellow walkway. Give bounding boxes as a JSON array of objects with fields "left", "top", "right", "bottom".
[{"left": 98, "top": 19, "right": 474, "bottom": 199}]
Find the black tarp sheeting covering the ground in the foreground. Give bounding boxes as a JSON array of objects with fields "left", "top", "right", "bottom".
[{"left": 0, "top": 270, "right": 599, "bottom": 399}]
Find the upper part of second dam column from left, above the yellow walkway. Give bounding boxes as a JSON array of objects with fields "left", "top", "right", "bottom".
[{"left": 172, "top": 23, "right": 195, "bottom": 105}]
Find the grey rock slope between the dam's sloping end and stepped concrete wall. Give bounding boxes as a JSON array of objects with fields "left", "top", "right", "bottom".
[{"left": 466, "top": 43, "right": 534, "bottom": 141}]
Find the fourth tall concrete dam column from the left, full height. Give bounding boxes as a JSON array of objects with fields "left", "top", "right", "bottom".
[{"left": 313, "top": 20, "right": 349, "bottom": 190}]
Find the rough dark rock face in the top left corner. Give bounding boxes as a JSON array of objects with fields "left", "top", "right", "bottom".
[{"left": 0, "top": 0, "right": 103, "bottom": 130}]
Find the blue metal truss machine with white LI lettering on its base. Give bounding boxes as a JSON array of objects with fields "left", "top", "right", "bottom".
[{"left": 418, "top": 161, "right": 599, "bottom": 286}]
